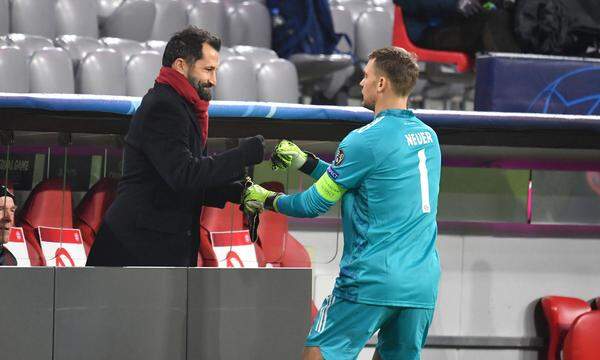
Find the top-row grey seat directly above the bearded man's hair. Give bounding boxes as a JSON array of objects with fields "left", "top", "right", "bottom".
[{"left": 188, "top": 0, "right": 230, "bottom": 45}]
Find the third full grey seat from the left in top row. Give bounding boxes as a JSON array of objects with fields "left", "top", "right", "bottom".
[{"left": 99, "top": 0, "right": 156, "bottom": 41}]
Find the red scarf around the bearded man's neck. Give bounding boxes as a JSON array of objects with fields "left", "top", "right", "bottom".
[{"left": 156, "top": 66, "right": 208, "bottom": 147}]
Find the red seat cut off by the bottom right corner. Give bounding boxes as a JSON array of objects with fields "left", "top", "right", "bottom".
[{"left": 562, "top": 311, "right": 600, "bottom": 360}]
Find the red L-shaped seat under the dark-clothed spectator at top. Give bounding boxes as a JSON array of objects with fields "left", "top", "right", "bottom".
[{"left": 392, "top": 6, "right": 473, "bottom": 73}]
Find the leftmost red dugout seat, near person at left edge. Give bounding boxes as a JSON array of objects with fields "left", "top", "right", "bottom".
[{"left": 15, "top": 179, "right": 73, "bottom": 266}]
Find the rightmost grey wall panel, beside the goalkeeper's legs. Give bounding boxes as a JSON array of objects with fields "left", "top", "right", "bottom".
[{"left": 188, "top": 269, "right": 311, "bottom": 360}]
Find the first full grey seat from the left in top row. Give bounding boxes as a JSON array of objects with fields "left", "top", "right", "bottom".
[{"left": 10, "top": 0, "right": 56, "bottom": 38}]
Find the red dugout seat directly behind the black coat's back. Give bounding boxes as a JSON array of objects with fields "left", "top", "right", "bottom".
[{"left": 73, "top": 178, "right": 118, "bottom": 255}]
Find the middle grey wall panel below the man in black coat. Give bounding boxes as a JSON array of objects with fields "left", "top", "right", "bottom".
[{"left": 54, "top": 268, "right": 187, "bottom": 360}]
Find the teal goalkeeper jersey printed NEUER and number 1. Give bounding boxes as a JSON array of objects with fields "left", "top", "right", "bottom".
[{"left": 327, "top": 110, "right": 441, "bottom": 308}]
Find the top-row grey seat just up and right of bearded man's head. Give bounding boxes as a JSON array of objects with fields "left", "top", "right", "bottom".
[{"left": 227, "top": 1, "right": 271, "bottom": 48}]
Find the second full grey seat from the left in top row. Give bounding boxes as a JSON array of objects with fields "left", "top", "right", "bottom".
[{"left": 55, "top": 0, "right": 98, "bottom": 38}]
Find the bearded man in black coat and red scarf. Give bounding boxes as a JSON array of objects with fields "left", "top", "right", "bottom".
[{"left": 87, "top": 27, "right": 264, "bottom": 266}]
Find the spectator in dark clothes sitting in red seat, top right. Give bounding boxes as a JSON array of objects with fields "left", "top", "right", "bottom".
[{"left": 394, "top": 0, "right": 521, "bottom": 54}]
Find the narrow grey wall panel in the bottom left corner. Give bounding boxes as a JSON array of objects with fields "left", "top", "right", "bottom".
[{"left": 0, "top": 267, "right": 54, "bottom": 360}]
